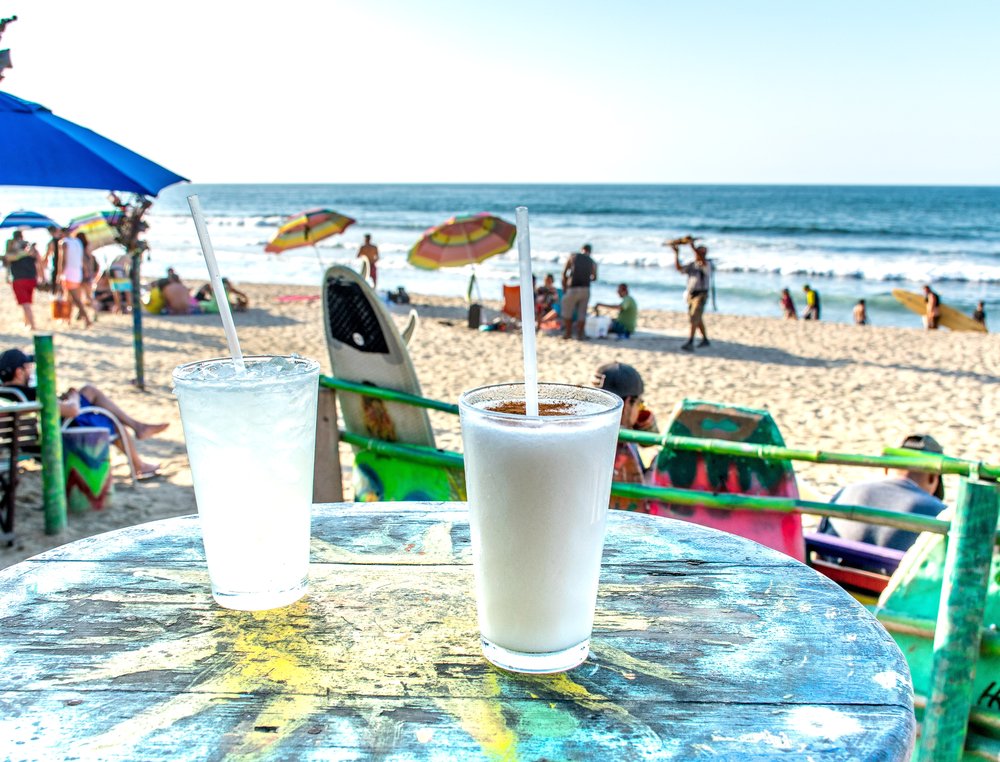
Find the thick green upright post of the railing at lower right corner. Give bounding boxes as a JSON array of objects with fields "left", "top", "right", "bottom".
[{"left": 920, "top": 479, "right": 1000, "bottom": 762}]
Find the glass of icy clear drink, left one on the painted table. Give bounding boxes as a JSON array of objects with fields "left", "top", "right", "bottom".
[{"left": 174, "top": 356, "right": 319, "bottom": 611}]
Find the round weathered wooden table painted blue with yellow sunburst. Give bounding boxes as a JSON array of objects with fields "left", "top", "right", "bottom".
[{"left": 0, "top": 503, "right": 914, "bottom": 761}]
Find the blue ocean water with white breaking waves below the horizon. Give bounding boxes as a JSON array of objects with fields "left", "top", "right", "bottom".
[{"left": 0, "top": 184, "right": 1000, "bottom": 327}]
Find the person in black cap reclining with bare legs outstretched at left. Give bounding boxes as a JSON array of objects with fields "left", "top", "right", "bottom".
[{"left": 0, "top": 348, "right": 170, "bottom": 479}]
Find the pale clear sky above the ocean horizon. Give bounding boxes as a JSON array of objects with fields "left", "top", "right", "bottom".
[{"left": 0, "top": 0, "right": 1000, "bottom": 185}]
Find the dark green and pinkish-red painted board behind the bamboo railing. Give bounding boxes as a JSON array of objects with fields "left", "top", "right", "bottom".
[{"left": 646, "top": 399, "right": 805, "bottom": 561}]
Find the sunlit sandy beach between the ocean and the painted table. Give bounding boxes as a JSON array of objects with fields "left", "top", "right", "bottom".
[{"left": 0, "top": 282, "right": 1000, "bottom": 567}]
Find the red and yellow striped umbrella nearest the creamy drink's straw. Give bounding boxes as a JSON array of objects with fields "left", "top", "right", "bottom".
[{"left": 407, "top": 212, "right": 517, "bottom": 270}]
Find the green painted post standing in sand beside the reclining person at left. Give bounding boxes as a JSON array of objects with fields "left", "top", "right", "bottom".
[{"left": 35, "top": 333, "right": 66, "bottom": 534}]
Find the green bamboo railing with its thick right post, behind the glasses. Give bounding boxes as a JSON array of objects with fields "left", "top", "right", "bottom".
[{"left": 320, "top": 376, "right": 1000, "bottom": 762}]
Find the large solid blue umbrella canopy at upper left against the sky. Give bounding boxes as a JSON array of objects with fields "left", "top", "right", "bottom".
[{"left": 0, "top": 93, "right": 187, "bottom": 196}]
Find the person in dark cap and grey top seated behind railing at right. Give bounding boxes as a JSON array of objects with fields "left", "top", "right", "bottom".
[{"left": 819, "top": 434, "right": 946, "bottom": 550}]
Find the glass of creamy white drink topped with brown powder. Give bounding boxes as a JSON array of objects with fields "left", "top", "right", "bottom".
[{"left": 459, "top": 383, "right": 622, "bottom": 673}]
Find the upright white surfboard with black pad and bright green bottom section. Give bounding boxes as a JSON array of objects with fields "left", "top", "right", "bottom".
[{"left": 323, "top": 265, "right": 465, "bottom": 502}]
